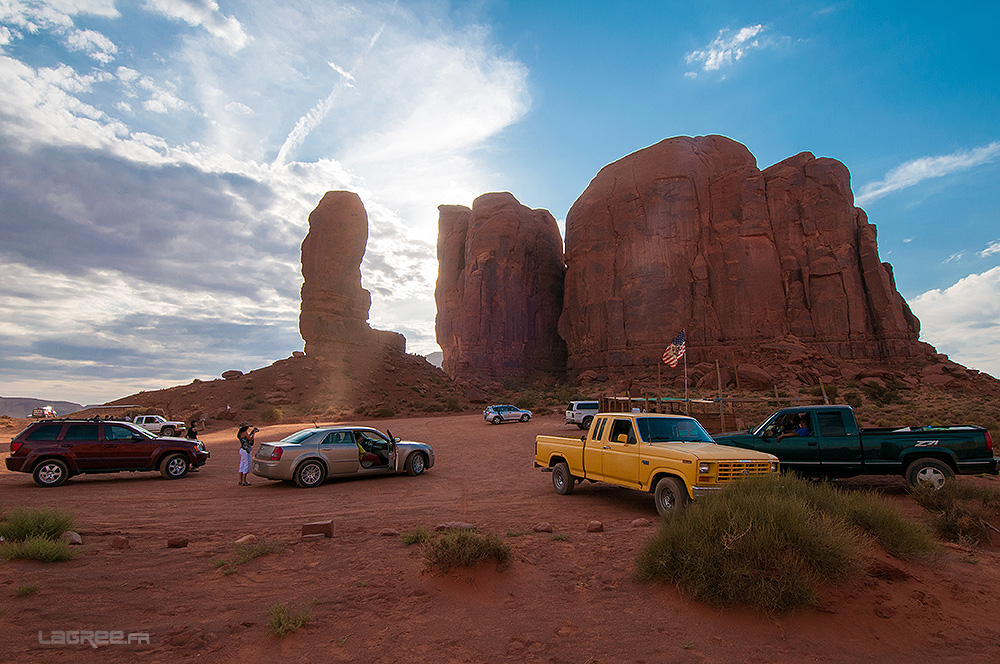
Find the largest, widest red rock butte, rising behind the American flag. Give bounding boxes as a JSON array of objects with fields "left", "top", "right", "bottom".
[{"left": 559, "top": 136, "right": 932, "bottom": 373}]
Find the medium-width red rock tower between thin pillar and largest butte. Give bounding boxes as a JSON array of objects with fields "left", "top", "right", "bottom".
[{"left": 435, "top": 193, "right": 566, "bottom": 377}]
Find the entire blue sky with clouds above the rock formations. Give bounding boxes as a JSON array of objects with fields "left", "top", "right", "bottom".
[{"left": 0, "top": 0, "right": 1000, "bottom": 403}]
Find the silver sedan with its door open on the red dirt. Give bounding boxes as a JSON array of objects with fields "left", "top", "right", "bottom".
[{"left": 252, "top": 426, "right": 434, "bottom": 487}]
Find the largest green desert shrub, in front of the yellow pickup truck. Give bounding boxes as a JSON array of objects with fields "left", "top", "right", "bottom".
[{"left": 637, "top": 476, "right": 933, "bottom": 612}]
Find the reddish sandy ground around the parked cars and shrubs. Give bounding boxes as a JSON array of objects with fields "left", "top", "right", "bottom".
[{"left": 0, "top": 415, "right": 1000, "bottom": 664}]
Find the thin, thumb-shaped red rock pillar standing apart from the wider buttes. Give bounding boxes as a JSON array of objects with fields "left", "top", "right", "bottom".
[{"left": 299, "top": 191, "right": 406, "bottom": 357}]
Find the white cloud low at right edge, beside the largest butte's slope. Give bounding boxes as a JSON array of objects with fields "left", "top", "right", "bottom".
[{"left": 909, "top": 267, "right": 1000, "bottom": 377}]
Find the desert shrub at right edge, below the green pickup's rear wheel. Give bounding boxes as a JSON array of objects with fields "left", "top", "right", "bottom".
[{"left": 910, "top": 481, "right": 1000, "bottom": 544}]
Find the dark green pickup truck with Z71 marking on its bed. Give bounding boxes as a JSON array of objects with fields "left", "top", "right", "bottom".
[{"left": 715, "top": 406, "right": 1000, "bottom": 487}]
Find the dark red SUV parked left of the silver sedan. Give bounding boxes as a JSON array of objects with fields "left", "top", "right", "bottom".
[{"left": 6, "top": 419, "right": 211, "bottom": 486}]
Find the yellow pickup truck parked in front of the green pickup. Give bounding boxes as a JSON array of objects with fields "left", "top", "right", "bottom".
[{"left": 535, "top": 413, "right": 779, "bottom": 514}]
